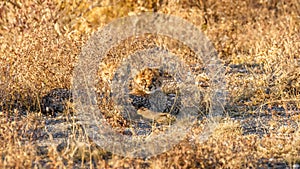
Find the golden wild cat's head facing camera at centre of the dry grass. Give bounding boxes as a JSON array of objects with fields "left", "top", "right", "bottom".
[{"left": 129, "top": 68, "right": 170, "bottom": 96}]
